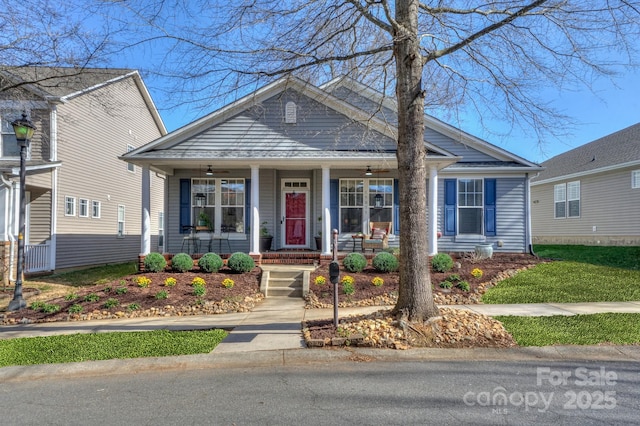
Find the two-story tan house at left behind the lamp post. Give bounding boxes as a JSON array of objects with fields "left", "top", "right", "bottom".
[{"left": 0, "top": 68, "right": 166, "bottom": 279}]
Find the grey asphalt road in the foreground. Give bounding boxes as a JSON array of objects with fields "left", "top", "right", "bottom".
[{"left": 0, "top": 361, "right": 640, "bottom": 425}]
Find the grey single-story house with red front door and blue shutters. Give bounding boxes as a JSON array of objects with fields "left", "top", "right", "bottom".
[{"left": 122, "top": 78, "right": 540, "bottom": 257}]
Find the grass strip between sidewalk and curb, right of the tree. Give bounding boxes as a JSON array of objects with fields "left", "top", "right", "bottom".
[{"left": 495, "top": 313, "right": 640, "bottom": 346}]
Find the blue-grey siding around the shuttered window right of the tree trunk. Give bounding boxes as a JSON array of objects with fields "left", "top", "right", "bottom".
[{"left": 438, "top": 176, "right": 527, "bottom": 253}]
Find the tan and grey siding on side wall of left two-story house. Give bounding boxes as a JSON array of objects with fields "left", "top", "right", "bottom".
[{"left": 56, "top": 78, "right": 164, "bottom": 269}]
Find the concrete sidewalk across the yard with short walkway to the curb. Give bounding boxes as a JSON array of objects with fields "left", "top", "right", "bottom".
[{"left": 0, "top": 297, "right": 640, "bottom": 353}]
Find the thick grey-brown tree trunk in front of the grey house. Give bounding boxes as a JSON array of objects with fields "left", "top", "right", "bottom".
[{"left": 393, "top": 0, "right": 438, "bottom": 321}]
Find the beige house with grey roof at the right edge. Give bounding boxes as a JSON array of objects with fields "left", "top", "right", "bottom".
[{"left": 531, "top": 123, "right": 640, "bottom": 246}]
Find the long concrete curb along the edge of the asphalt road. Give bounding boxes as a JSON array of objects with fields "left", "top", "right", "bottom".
[{"left": 0, "top": 345, "right": 640, "bottom": 383}]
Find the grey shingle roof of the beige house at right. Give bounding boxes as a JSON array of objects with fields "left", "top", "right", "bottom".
[{"left": 532, "top": 123, "right": 640, "bottom": 182}]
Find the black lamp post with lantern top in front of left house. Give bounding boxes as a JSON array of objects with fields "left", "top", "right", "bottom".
[{"left": 7, "top": 112, "right": 36, "bottom": 311}]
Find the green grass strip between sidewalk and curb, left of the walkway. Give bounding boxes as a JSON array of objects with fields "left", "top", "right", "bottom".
[{"left": 0, "top": 329, "right": 228, "bottom": 367}]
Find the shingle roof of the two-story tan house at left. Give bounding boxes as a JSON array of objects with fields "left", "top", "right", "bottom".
[{"left": 0, "top": 67, "right": 133, "bottom": 97}]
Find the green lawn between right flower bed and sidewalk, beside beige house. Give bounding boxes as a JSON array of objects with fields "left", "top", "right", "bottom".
[{"left": 482, "top": 261, "right": 640, "bottom": 304}]
